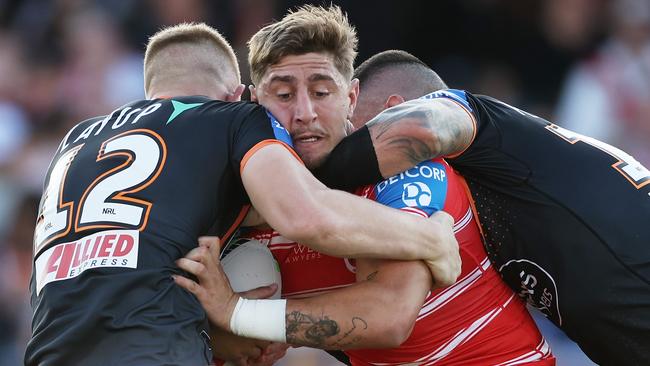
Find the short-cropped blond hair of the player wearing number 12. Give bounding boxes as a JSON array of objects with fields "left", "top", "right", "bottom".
[{"left": 144, "top": 23, "right": 241, "bottom": 95}]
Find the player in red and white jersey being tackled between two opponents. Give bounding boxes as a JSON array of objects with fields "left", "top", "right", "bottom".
[{"left": 177, "top": 6, "right": 555, "bottom": 365}]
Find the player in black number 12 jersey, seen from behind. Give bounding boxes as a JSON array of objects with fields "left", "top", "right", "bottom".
[{"left": 25, "top": 24, "right": 460, "bottom": 366}]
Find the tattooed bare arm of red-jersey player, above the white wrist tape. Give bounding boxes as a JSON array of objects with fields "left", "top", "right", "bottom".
[{"left": 286, "top": 259, "right": 431, "bottom": 349}]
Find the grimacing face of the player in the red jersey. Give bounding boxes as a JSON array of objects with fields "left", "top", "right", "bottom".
[{"left": 252, "top": 53, "right": 359, "bottom": 169}]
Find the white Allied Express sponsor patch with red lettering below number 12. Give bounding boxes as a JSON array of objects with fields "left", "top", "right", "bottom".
[{"left": 35, "top": 230, "right": 140, "bottom": 295}]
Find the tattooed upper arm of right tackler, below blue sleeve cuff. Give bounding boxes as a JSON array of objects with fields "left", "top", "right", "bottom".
[{"left": 367, "top": 98, "right": 474, "bottom": 178}]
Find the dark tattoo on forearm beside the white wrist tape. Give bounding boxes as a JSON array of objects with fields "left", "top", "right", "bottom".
[{"left": 286, "top": 311, "right": 368, "bottom": 348}]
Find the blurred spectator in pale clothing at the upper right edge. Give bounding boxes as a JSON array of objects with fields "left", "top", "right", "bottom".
[{"left": 557, "top": 0, "right": 650, "bottom": 166}]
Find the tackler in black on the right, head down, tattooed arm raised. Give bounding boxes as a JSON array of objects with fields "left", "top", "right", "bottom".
[{"left": 316, "top": 51, "right": 650, "bottom": 365}]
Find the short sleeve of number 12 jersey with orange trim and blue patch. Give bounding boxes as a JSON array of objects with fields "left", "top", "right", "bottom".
[{"left": 231, "top": 106, "right": 301, "bottom": 173}]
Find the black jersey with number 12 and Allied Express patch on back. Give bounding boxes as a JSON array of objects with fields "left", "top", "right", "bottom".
[{"left": 25, "top": 97, "right": 290, "bottom": 366}]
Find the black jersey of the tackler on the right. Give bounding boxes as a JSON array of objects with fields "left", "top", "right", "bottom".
[{"left": 426, "top": 90, "right": 650, "bottom": 365}]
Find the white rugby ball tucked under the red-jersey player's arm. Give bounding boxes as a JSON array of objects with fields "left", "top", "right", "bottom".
[{"left": 221, "top": 240, "right": 282, "bottom": 299}]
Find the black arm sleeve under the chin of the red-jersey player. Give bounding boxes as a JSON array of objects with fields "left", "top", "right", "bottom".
[{"left": 313, "top": 126, "right": 384, "bottom": 192}]
